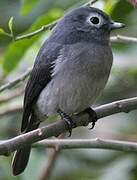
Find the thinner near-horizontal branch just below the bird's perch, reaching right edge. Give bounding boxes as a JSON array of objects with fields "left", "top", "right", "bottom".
[{"left": 33, "top": 138, "right": 137, "bottom": 152}]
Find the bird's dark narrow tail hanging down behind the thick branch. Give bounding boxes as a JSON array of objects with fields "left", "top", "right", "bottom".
[{"left": 12, "top": 115, "right": 40, "bottom": 176}]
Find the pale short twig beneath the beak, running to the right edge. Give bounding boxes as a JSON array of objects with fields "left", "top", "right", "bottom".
[{"left": 110, "top": 35, "right": 137, "bottom": 43}]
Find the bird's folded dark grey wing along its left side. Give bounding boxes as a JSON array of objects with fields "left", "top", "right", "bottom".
[{"left": 21, "top": 43, "right": 61, "bottom": 132}]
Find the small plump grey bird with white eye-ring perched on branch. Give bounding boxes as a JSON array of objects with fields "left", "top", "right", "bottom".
[{"left": 12, "top": 6, "right": 124, "bottom": 175}]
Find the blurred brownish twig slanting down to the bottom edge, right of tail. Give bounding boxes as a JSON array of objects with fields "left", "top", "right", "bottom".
[{"left": 39, "top": 133, "right": 65, "bottom": 180}]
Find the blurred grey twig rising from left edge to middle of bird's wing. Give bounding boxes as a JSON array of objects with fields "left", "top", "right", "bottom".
[{"left": 0, "top": 69, "right": 31, "bottom": 92}]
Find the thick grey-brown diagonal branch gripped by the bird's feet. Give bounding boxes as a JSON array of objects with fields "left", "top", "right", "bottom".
[{"left": 0, "top": 97, "right": 137, "bottom": 155}]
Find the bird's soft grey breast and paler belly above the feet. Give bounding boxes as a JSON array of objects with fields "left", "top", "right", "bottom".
[{"left": 36, "top": 43, "right": 113, "bottom": 116}]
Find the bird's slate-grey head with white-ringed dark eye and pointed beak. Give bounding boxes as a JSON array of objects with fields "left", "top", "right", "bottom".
[{"left": 50, "top": 6, "right": 125, "bottom": 44}]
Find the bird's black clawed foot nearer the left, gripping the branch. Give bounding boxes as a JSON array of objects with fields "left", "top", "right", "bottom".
[{"left": 57, "top": 109, "right": 76, "bottom": 137}]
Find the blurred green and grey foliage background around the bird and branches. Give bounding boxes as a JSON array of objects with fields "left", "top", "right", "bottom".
[{"left": 0, "top": 0, "right": 137, "bottom": 180}]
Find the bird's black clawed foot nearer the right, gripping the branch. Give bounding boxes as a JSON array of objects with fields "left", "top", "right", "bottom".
[{"left": 83, "top": 107, "right": 98, "bottom": 130}]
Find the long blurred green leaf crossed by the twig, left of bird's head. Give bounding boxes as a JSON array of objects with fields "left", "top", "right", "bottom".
[{"left": 1, "top": 9, "right": 63, "bottom": 75}]
